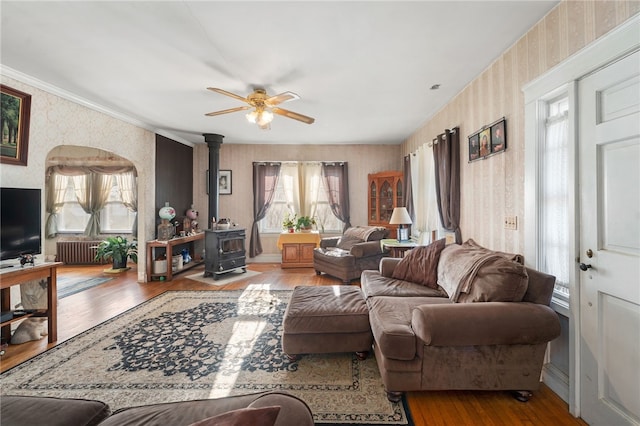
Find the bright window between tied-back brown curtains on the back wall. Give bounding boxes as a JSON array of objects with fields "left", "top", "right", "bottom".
[{"left": 259, "top": 162, "right": 343, "bottom": 233}]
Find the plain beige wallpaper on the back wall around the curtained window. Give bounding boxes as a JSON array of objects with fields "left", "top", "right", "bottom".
[{"left": 193, "top": 143, "right": 402, "bottom": 260}]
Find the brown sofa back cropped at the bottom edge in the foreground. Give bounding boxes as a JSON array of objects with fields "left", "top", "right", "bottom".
[{"left": 0, "top": 391, "right": 314, "bottom": 426}]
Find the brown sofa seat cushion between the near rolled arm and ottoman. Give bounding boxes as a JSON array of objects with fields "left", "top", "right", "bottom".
[{"left": 367, "top": 296, "right": 451, "bottom": 361}]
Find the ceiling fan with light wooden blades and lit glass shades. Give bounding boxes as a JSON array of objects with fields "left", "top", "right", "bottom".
[{"left": 205, "top": 87, "right": 315, "bottom": 130}]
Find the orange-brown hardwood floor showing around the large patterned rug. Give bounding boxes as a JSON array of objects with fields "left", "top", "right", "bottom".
[{"left": 0, "top": 263, "right": 586, "bottom": 426}]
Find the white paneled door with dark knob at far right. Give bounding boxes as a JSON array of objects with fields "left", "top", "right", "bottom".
[{"left": 578, "top": 52, "right": 640, "bottom": 425}]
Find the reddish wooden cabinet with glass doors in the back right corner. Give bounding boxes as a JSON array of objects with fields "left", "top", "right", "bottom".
[{"left": 368, "top": 171, "right": 404, "bottom": 235}]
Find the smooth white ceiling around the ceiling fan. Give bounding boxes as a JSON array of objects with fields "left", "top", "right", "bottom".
[{"left": 0, "top": 0, "right": 558, "bottom": 144}]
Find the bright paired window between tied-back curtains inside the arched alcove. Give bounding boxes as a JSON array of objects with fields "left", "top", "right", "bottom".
[{"left": 58, "top": 175, "right": 136, "bottom": 233}]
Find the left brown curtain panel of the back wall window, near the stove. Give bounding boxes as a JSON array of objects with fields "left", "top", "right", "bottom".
[{"left": 249, "top": 163, "right": 280, "bottom": 257}]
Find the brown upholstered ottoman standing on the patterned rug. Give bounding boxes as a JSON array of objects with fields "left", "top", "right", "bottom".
[{"left": 282, "top": 285, "right": 373, "bottom": 359}]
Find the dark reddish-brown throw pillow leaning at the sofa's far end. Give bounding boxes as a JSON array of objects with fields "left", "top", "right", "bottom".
[{"left": 391, "top": 238, "right": 445, "bottom": 288}]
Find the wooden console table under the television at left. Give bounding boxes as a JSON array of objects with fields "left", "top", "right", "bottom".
[{"left": 0, "top": 262, "right": 62, "bottom": 343}]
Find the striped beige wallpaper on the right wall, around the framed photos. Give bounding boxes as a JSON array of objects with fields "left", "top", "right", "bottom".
[{"left": 402, "top": 0, "right": 640, "bottom": 253}]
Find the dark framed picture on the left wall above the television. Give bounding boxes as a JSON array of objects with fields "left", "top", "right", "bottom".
[{"left": 0, "top": 84, "right": 31, "bottom": 166}]
